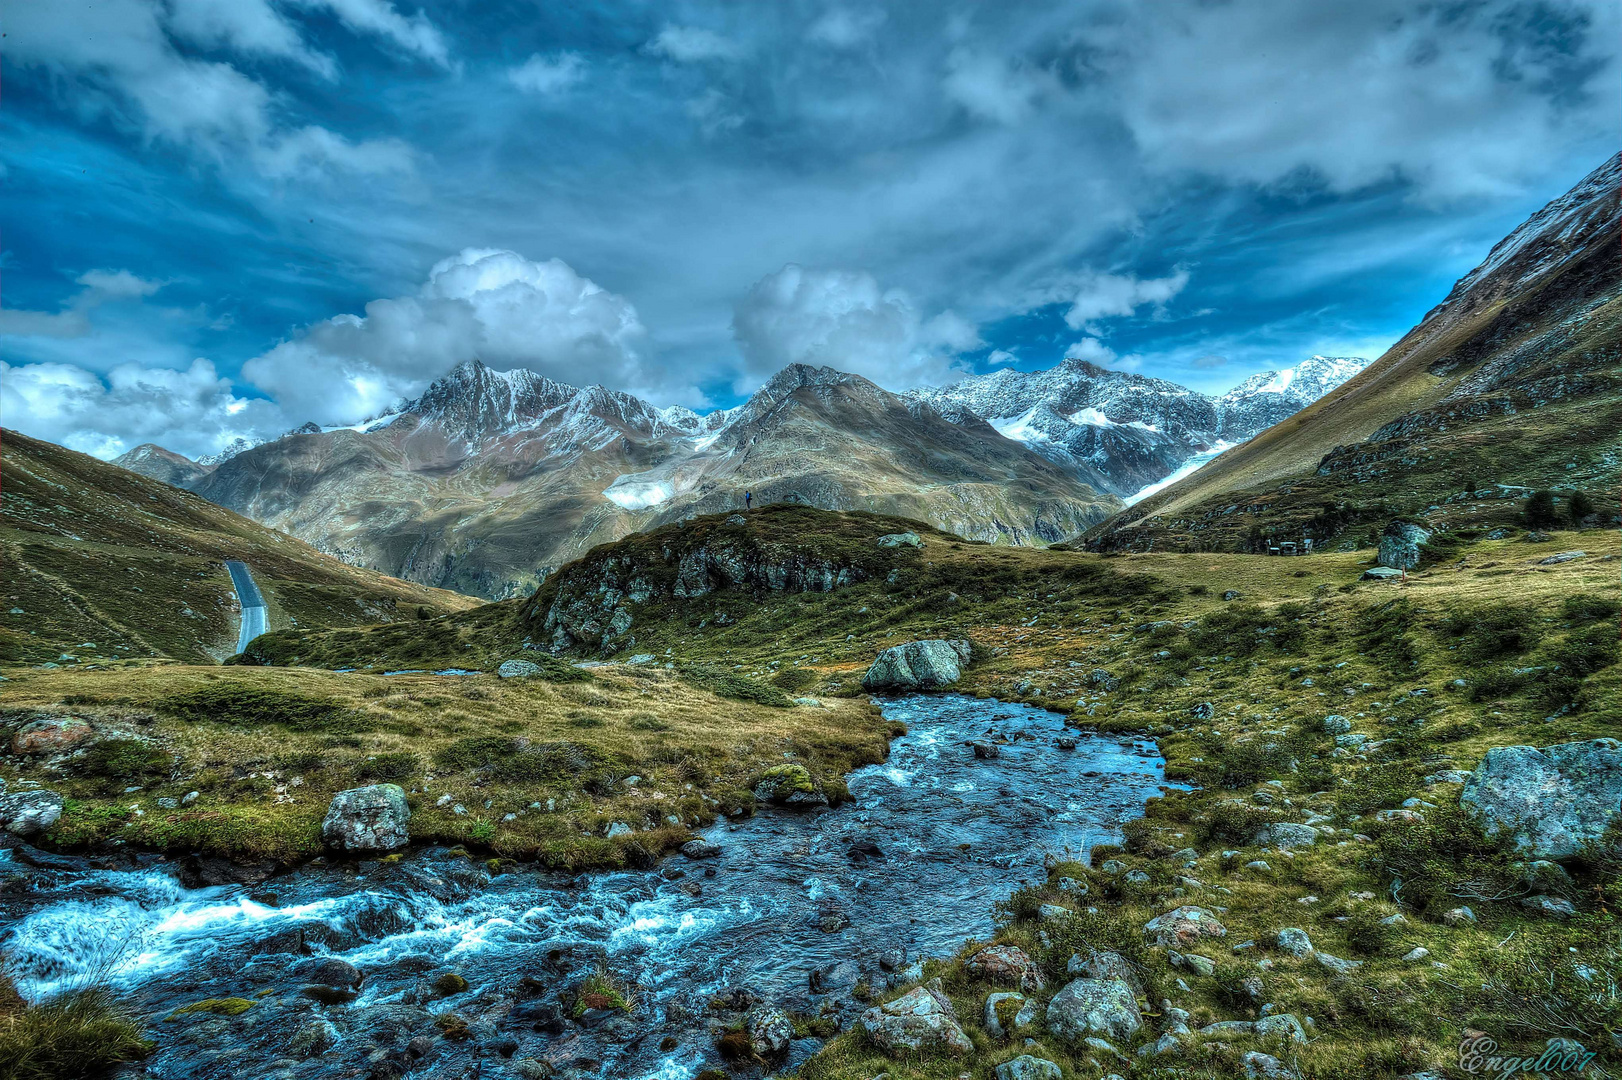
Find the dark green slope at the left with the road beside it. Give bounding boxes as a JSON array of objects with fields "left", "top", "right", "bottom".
[{"left": 0, "top": 431, "right": 474, "bottom": 663}]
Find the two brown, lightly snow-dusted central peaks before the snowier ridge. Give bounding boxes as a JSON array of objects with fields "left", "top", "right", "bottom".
[{"left": 127, "top": 360, "right": 1119, "bottom": 598}]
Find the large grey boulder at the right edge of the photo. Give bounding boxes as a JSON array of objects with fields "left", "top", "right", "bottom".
[{"left": 1458, "top": 739, "right": 1622, "bottom": 859}]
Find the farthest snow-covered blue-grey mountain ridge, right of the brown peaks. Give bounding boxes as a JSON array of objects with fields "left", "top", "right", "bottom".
[{"left": 910, "top": 357, "right": 1367, "bottom": 495}]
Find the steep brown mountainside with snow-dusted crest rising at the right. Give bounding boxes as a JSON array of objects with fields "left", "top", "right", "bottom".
[{"left": 1090, "top": 154, "right": 1622, "bottom": 550}]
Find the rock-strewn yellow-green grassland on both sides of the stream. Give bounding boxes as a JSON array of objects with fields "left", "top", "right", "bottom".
[{"left": 10, "top": 509, "right": 1622, "bottom": 1080}]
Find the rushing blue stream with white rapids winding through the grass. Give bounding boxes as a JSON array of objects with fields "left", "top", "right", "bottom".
[{"left": 0, "top": 696, "right": 1163, "bottom": 1080}]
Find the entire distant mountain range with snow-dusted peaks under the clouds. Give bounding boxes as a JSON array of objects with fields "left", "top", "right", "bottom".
[{"left": 107, "top": 348, "right": 1361, "bottom": 598}]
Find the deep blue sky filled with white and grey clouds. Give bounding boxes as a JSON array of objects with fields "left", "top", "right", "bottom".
[{"left": 0, "top": 0, "right": 1622, "bottom": 457}]
